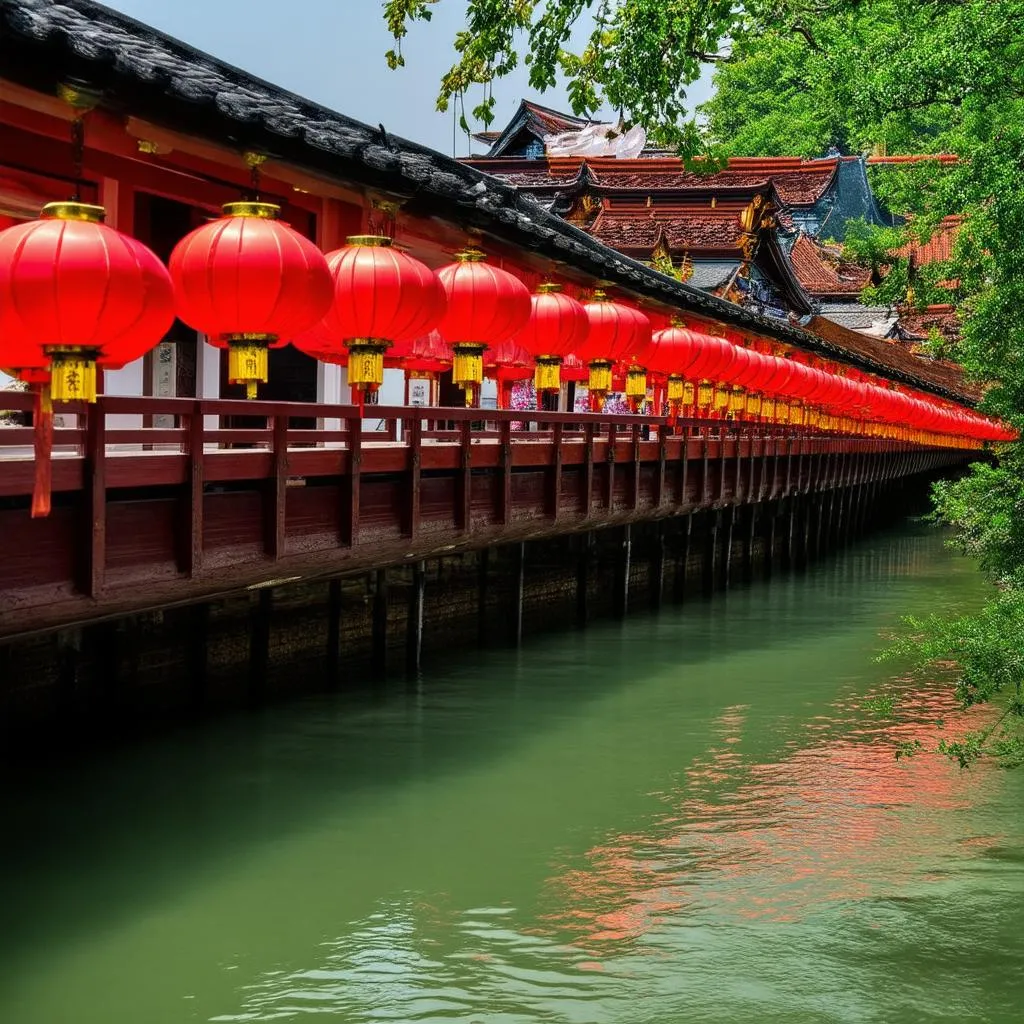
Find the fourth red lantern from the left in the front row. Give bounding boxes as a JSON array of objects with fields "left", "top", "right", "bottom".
[{"left": 437, "top": 249, "right": 530, "bottom": 401}]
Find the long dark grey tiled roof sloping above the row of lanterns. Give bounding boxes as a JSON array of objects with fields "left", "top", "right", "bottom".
[{"left": 0, "top": 0, "right": 963, "bottom": 398}]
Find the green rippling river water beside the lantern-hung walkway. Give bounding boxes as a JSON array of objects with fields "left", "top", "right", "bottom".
[{"left": 0, "top": 527, "right": 1024, "bottom": 1024}]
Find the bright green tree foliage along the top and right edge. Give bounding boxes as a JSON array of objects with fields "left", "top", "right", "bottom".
[{"left": 393, "top": 0, "right": 1024, "bottom": 764}]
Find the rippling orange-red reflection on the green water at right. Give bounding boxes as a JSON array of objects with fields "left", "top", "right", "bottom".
[{"left": 542, "top": 690, "right": 994, "bottom": 948}]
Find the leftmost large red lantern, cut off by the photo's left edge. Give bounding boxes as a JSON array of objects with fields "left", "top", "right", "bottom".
[{"left": 0, "top": 202, "right": 174, "bottom": 401}]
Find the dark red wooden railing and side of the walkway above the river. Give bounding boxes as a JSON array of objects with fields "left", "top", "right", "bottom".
[{"left": 0, "top": 397, "right": 973, "bottom": 637}]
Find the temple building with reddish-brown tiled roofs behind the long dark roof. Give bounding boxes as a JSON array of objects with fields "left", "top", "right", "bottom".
[{"left": 466, "top": 100, "right": 955, "bottom": 352}]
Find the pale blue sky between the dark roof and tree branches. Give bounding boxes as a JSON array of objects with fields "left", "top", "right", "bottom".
[{"left": 103, "top": 0, "right": 710, "bottom": 156}]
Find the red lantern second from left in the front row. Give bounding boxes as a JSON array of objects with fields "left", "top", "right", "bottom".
[{"left": 170, "top": 202, "right": 333, "bottom": 398}]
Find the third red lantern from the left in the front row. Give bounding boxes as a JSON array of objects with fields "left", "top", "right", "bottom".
[{"left": 293, "top": 234, "right": 444, "bottom": 402}]
